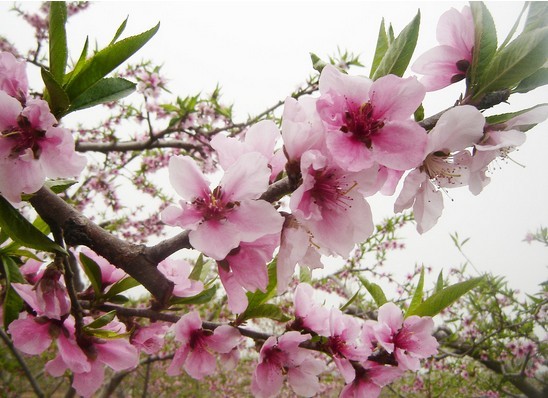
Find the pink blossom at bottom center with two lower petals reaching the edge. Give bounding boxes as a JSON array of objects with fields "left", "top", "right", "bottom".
[{"left": 251, "top": 332, "right": 324, "bottom": 398}]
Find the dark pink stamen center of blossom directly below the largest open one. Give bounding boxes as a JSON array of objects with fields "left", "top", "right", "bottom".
[{"left": 310, "top": 169, "right": 356, "bottom": 211}]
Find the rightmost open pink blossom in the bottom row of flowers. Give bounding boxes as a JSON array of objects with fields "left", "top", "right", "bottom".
[{"left": 374, "top": 303, "right": 439, "bottom": 370}]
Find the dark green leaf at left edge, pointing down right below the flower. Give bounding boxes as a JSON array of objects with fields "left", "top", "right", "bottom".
[{"left": 0, "top": 196, "right": 67, "bottom": 254}]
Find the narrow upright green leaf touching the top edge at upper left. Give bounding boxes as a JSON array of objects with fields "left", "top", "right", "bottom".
[{"left": 49, "top": 1, "right": 68, "bottom": 82}]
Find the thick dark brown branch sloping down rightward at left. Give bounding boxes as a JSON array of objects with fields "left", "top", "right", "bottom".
[{"left": 30, "top": 187, "right": 173, "bottom": 305}]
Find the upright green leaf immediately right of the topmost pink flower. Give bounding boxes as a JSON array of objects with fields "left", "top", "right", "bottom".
[{"left": 469, "top": 1, "right": 497, "bottom": 92}]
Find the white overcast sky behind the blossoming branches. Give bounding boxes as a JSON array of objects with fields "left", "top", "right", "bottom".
[{"left": 0, "top": 1, "right": 548, "bottom": 293}]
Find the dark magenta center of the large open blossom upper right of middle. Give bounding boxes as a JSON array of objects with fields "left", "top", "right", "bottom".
[{"left": 341, "top": 102, "right": 384, "bottom": 148}]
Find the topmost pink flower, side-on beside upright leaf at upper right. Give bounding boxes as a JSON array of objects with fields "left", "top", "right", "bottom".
[{"left": 411, "top": 6, "right": 475, "bottom": 91}]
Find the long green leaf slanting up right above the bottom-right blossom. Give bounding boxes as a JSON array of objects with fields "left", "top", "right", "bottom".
[{"left": 406, "top": 277, "right": 484, "bottom": 316}]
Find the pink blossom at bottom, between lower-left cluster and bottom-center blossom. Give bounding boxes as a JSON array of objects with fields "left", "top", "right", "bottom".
[{"left": 167, "top": 311, "right": 241, "bottom": 380}]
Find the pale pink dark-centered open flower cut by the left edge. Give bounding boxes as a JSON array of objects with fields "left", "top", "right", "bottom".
[{"left": 0, "top": 91, "right": 86, "bottom": 202}]
